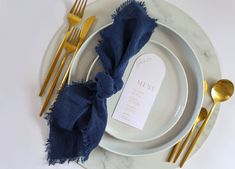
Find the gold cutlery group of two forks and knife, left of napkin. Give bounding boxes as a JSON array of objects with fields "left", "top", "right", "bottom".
[{"left": 39, "top": 0, "right": 96, "bottom": 116}]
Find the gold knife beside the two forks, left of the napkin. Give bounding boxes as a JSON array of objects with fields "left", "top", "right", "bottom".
[{"left": 60, "top": 16, "right": 96, "bottom": 89}]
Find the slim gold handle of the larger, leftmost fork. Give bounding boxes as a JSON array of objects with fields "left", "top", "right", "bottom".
[{"left": 39, "top": 35, "right": 67, "bottom": 96}]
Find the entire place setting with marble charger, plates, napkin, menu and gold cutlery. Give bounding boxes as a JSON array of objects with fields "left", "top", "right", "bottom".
[{"left": 38, "top": 0, "right": 234, "bottom": 169}]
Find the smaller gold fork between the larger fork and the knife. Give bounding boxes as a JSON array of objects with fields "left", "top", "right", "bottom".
[{"left": 40, "top": 27, "right": 80, "bottom": 116}]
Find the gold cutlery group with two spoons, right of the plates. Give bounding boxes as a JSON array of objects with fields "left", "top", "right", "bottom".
[{"left": 167, "top": 79, "right": 234, "bottom": 167}]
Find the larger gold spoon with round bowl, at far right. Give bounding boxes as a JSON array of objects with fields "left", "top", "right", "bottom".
[{"left": 180, "top": 79, "right": 234, "bottom": 167}]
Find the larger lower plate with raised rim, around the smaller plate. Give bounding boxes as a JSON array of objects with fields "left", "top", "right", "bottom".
[{"left": 69, "top": 23, "right": 203, "bottom": 156}]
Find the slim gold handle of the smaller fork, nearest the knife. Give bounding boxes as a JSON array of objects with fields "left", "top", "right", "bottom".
[{"left": 40, "top": 52, "right": 69, "bottom": 117}]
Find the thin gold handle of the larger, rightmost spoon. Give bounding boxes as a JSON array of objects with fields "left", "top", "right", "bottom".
[{"left": 180, "top": 103, "right": 217, "bottom": 167}]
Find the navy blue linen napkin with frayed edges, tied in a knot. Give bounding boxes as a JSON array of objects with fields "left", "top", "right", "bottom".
[{"left": 46, "top": 0, "right": 157, "bottom": 164}]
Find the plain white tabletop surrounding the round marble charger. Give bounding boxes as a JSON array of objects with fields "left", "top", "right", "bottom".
[{"left": 0, "top": 0, "right": 235, "bottom": 169}]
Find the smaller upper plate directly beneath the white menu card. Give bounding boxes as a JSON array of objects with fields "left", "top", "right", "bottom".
[{"left": 85, "top": 40, "right": 188, "bottom": 142}]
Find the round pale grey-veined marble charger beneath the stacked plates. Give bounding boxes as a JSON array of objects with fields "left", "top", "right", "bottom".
[{"left": 40, "top": 0, "right": 221, "bottom": 169}]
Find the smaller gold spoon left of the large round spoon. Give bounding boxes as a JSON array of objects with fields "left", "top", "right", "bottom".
[{"left": 173, "top": 107, "right": 208, "bottom": 163}]
